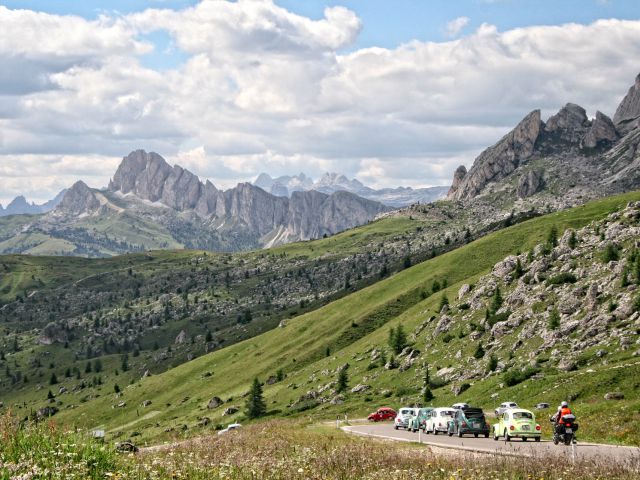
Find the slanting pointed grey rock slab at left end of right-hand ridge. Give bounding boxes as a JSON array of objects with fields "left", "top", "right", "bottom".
[{"left": 448, "top": 110, "right": 543, "bottom": 200}]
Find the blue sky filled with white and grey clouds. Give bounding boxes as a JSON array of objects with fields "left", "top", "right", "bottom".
[{"left": 0, "top": 0, "right": 640, "bottom": 205}]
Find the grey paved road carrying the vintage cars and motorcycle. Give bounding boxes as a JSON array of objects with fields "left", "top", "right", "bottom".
[{"left": 343, "top": 423, "right": 640, "bottom": 463}]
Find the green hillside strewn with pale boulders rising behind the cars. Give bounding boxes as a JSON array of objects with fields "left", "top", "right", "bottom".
[{"left": 5, "top": 189, "right": 640, "bottom": 443}]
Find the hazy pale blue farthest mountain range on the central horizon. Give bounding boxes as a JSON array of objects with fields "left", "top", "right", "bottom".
[{"left": 253, "top": 172, "right": 449, "bottom": 208}]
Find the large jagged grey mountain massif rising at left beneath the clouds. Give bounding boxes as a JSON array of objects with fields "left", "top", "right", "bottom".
[{"left": 0, "top": 150, "right": 390, "bottom": 256}]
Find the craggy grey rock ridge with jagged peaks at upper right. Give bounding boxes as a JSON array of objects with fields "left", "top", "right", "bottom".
[{"left": 448, "top": 75, "right": 640, "bottom": 204}]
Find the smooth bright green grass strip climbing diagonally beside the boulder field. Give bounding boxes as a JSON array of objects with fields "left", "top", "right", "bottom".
[{"left": 51, "top": 189, "right": 640, "bottom": 444}]
